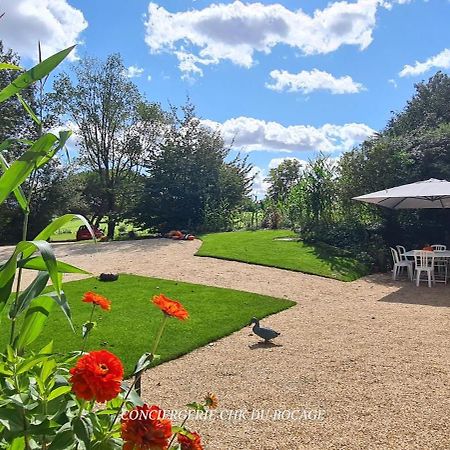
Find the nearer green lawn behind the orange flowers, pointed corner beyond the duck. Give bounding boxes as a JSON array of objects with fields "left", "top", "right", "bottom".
[{"left": 0, "top": 275, "right": 295, "bottom": 374}]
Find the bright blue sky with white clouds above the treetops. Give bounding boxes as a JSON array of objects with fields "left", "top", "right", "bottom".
[{"left": 0, "top": 0, "right": 450, "bottom": 193}]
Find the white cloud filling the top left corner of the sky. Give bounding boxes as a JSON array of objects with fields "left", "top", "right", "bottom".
[{"left": 0, "top": 0, "right": 88, "bottom": 61}]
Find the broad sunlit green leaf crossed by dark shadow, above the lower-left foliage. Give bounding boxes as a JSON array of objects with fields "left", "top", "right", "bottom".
[{"left": 17, "top": 295, "right": 54, "bottom": 349}]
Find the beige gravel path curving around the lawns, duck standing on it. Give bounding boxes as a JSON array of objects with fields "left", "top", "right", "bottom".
[{"left": 0, "top": 240, "right": 450, "bottom": 450}]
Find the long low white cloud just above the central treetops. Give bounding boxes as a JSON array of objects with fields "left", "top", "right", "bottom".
[{"left": 203, "top": 117, "right": 375, "bottom": 153}]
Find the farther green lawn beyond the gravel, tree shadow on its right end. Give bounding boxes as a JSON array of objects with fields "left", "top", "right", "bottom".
[{"left": 197, "top": 230, "right": 367, "bottom": 281}]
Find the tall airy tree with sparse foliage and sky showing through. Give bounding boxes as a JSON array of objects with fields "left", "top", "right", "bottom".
[{"left": 52, "top": 54, "right": 165, "bottom": 238}]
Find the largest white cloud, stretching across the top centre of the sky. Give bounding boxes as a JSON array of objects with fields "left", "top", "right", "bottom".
[{"left": 145, "top": 0, "right": 380, "bottom": 75}]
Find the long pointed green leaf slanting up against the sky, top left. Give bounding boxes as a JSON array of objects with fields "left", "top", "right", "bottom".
[{"left": 0, "top": 45, "right": 75, "bottom": 103}]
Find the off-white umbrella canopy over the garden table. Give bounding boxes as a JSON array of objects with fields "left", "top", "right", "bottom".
[{"left": 353, "top": 178, "right": 450, "bottom": 209}]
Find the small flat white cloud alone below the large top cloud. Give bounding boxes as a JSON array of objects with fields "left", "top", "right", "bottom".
[{"left": 266, "top": 69, "right": 364, "bottom": 94}]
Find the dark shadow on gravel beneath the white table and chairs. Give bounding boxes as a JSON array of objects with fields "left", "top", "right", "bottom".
[{"left": 366, "top": 274, "right": 450, "bottom": 308}]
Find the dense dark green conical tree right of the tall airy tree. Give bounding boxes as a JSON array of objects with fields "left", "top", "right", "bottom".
[{"left": 135, "top": 104, "right": 251, "bottom": 231}]
